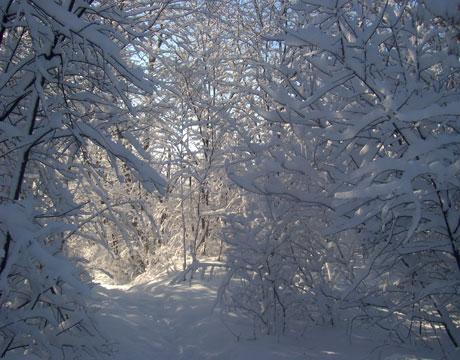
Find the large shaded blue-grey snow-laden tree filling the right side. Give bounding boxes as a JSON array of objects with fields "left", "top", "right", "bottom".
[{"left": 219, "top": 1, "right": 460, "bottom": 347}]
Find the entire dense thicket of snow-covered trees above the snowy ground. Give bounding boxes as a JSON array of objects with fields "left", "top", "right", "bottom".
[{"left": 0, "top": 0, "right": 460, "bottom": 356}]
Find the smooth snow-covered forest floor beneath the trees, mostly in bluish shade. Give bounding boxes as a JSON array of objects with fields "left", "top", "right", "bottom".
[{"left": 94, "top": 275, "right": 440, "bottom": 360}]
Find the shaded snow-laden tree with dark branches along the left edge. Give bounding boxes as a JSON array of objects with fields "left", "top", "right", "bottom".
[{"left": 0, "top": 0, "right": 165, "bottom": 359}]
